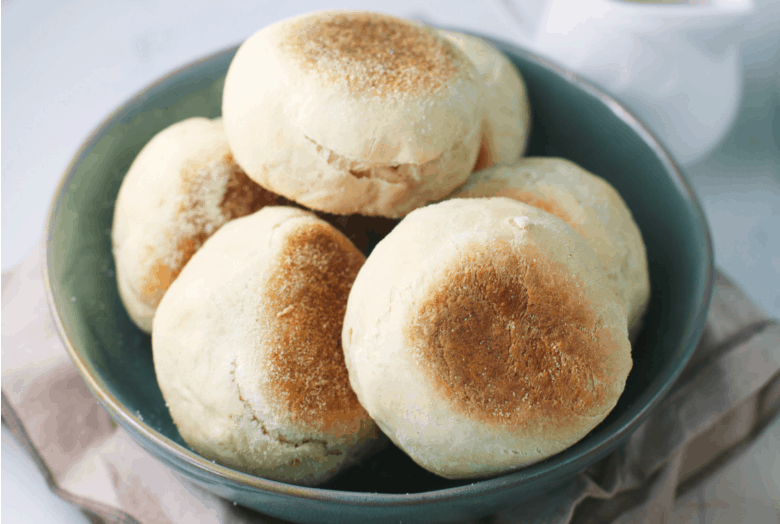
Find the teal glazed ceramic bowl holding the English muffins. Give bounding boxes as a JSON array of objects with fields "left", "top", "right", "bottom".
[{"left": 46, "top": 32, "right": 713, "bottom": 523}]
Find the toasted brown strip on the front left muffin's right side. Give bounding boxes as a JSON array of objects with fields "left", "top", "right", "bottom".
[{"left": 264, "top": 220, "right": 367, "bottom": 431}]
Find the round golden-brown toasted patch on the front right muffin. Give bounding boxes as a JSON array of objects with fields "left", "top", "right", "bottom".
[{"left": 406, "top": 244, "right": 617, "bottom": 429}]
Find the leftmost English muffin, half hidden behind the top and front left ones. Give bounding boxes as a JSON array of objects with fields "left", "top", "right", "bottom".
[{"left": 111, "top": 118, "right": 278, "bottom": 333}]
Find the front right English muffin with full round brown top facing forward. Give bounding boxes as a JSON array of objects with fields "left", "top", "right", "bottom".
[{"left": 342, "top": 198, "right": 631, "bottom": 478}]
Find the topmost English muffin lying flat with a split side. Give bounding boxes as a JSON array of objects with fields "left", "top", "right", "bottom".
[{"left": 222, "top": 11, "right": 483, "bottom": 218}]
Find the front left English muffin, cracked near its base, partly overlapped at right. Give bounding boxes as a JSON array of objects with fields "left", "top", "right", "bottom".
[{"left": 152, "top": 206, "right": 382, "bottom": 485}]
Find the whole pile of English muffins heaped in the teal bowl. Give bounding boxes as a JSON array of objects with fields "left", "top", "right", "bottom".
[{"left": 106, "top": 11, "right": 650, "bottom": 492}]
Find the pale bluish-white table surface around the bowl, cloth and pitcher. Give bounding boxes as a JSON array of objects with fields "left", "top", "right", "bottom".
[{"left": 1, "top": 0, "right": 780, "bottom": 523}]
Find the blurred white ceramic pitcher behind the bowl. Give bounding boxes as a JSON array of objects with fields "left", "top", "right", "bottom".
[{"left": 502, "top": 0, "right": 760, "bottom": 164}]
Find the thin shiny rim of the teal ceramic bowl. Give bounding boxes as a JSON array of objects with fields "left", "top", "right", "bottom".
[{"left": 41, "top": 26, "right": 715, "bottom": 507}]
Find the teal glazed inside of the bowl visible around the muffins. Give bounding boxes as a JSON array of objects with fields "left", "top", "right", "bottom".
[{"left": 47, "top": 42, "right": 712, "bottom": 500}]
